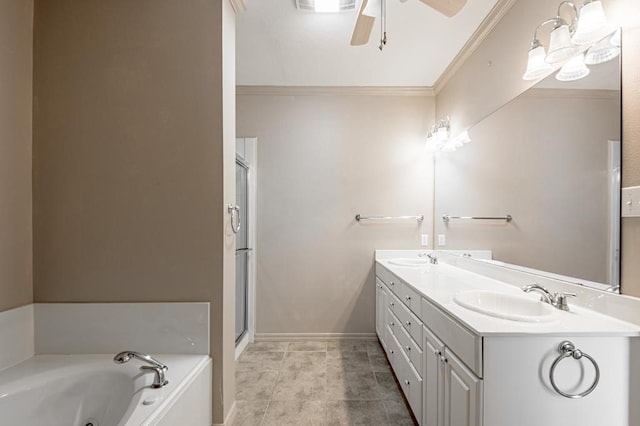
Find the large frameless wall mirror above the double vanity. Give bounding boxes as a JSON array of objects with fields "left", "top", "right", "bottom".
[{"left": 435, "top": 28, "right": 621, "bottom": 289}]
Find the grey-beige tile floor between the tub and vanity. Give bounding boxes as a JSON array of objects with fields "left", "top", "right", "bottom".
[{"left": 233, "top": 340, "right": 417, "bottom": 426}]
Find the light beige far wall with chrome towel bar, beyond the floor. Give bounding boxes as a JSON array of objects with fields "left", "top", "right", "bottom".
[{"left": 237, "top": 89, "right": 434, "bottom": 335}]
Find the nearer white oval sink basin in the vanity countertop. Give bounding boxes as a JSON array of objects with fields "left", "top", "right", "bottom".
[{"left": 453, "top": 290, "right": 556, "bottom": 322}]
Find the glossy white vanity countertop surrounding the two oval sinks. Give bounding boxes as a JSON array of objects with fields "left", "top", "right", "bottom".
[{"left": 376, "top": 256, "right": 640, "bottom": 336}]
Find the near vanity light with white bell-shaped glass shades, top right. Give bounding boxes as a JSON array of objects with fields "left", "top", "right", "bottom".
[{"left": 522, "top": 0, "right": 620, "bottom": 81}]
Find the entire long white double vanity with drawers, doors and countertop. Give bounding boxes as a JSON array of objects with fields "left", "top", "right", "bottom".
[{"left": 376, "top": 251, "right": 640, "bottom": 426}]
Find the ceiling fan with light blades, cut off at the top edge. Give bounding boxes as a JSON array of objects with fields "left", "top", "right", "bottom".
[{"left": 351, "top": 0, "right": 467, "bottom": 50}]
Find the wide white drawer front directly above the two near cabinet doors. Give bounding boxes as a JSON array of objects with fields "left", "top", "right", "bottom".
[{"left": 420, "top": 298, "right": 482, "bottom": 377}]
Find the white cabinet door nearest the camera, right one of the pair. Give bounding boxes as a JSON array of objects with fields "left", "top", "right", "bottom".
[{"left": 444, "top": 349, "right": 482, "bottom": 426}]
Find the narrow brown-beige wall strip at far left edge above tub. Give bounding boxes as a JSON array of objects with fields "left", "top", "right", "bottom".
[{"left": 0, "top": 0, "right": 33, "bottom": 311}]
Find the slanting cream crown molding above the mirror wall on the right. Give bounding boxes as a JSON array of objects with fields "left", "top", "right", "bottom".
[{"left": 433, "top": 0, "right": 517, "bottom": 95}]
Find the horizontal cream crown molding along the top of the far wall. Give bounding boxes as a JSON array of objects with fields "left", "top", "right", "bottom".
[{"left": 236, "top": 86, "right": 435, "bottom": 97}]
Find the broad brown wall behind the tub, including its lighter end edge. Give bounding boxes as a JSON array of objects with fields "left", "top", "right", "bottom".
[{"left": 33, "top": 0, "right": 235, "bottom": 423}]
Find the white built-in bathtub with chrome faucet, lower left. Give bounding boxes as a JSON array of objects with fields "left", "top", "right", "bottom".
[{"left": 0, "top": 348, "right": 211, "bottom": 426}]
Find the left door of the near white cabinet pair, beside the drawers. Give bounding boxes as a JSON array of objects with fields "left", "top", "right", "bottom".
[{"left": 422, "top": 327, "right": 444, "bottom": 426}]
